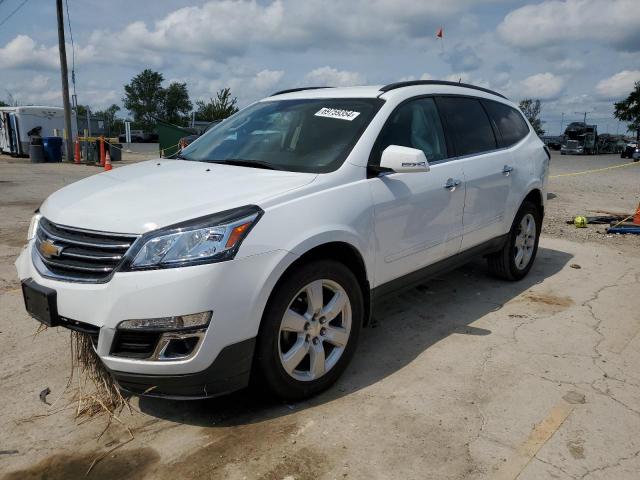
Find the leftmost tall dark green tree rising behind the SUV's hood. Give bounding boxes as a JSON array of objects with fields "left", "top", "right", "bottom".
[{"left": 122, "top": 68, "right": 165, "bottom": 131}]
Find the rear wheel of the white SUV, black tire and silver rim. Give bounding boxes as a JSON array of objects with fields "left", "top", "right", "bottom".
[{"left": 487, "top": 201, "right": 542, "bottom": 281}]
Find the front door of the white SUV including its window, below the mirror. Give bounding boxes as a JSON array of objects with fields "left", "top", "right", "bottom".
[{"left": 369, "top": 97, "right": 464, "bottom": 286}]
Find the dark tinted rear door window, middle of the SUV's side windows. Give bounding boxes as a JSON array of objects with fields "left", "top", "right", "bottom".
[{"left": 438, "top": 97, "right": 497, "bottom": 156}]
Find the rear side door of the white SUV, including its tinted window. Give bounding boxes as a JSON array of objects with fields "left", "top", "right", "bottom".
[{"left": 437, "top": 96, "right": 513, "bottom": 250}]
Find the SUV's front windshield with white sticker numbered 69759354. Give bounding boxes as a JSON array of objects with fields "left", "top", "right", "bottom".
[{"left": 179, "top": 98, "right": 384, "bottom": 173}]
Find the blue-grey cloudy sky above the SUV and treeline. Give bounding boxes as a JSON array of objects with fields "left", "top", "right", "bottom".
[{"left": 0, "top": 0, "right": 640, "bottom": 133}]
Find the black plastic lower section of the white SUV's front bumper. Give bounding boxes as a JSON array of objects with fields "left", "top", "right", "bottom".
[{"left": 109, "top": 338, "right": 256, "bottom": 400}]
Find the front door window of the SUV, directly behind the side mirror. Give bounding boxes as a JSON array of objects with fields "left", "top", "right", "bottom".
[{"left": 379, "top": 98, "right": 447, "bottom": 162}]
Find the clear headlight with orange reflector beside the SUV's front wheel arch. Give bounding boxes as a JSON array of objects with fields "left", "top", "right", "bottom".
[{"left": 125, "top": 205, "right": 263, "bottom": 270}]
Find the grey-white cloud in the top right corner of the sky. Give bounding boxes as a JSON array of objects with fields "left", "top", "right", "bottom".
[{"left": 498, "top": 0, "right": 640, "bottom": 51}]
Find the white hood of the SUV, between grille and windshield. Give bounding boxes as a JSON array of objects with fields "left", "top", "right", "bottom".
[{"left": 40, "top": 160, "right": 317, "bottom": 233}]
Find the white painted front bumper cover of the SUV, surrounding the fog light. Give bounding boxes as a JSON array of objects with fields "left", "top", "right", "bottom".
[{"left": 16, "top": 241, "right": 296, "bottom": 384}]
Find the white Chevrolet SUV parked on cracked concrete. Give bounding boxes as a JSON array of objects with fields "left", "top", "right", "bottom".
[{"left": 16, "top": 81, "right": 550, "bottom": 399}]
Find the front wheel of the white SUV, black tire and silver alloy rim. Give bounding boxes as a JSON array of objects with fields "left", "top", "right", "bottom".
[{"left": 252, "top": 260, "right": 364, "bottom": 401}]
